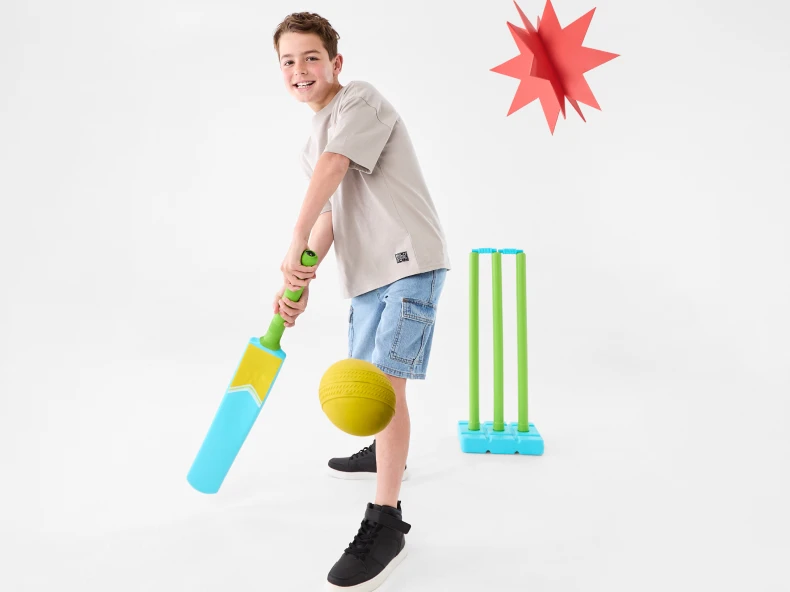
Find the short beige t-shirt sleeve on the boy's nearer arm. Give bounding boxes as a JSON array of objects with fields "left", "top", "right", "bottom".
[{"left": 324, "top": 96, "right": 392, "bottom": 174}]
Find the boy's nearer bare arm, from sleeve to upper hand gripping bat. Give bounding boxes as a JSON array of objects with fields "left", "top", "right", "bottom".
[{"left": 282, "top": 152, "right": 350, "bottom": 290}]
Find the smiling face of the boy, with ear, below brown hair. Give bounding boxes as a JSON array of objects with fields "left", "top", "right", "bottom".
[{"left": 279, "top": 33, "right": 343, "bottom": 111}]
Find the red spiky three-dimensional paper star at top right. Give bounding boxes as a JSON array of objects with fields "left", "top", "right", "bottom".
[{"left": 491, "top": 0, "right": 618, "bottom": 135}]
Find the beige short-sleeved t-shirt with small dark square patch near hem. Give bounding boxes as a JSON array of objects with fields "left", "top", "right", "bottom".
[{"left": 302, "top": 81, "right": 450, "bottom": 298}]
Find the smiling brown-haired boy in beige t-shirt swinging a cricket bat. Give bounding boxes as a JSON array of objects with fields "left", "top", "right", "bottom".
[{"left": 274, "top": 12, "right": 450, "bottom": 592}]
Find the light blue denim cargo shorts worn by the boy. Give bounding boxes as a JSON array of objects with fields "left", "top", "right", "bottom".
[{"left": 348, "top": 269, "right": 447, "bottom": 380}]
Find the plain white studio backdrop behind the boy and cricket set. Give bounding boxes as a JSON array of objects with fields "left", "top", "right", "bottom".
[{"left": 0, "top": 0, "right": 790, "bottom": 592}]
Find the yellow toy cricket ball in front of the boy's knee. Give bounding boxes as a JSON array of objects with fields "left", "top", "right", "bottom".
[{"left": 318, "top": 358, "right": 395, "bottom": 436}]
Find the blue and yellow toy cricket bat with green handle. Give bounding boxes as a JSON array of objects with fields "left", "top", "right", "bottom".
[{"left": 187, "top": 250, "right": 318, "bottom": 493}]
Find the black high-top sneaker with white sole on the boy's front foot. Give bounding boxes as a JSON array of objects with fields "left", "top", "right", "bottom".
[{"left": 326, "top": 501, "right": 411, "bottom": 592}]
